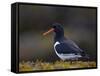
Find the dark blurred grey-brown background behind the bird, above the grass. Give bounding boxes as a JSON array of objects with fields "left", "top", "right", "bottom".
[{"left": 19, "top": 5, "right": 97, "bottom": 62}]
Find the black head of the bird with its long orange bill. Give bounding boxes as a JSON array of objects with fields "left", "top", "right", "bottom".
[{"left": 43, "top": 23, "right": 64, "bottom": 36}]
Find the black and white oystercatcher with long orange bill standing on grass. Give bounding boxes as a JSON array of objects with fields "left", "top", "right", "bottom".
[{"left": 43, "top": 23, "right": 88, "bottom": 61}]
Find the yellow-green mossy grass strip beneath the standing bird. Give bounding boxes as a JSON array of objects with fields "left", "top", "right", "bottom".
[{"left": 19, "top": 60, "right": 96, "bottom": 72}]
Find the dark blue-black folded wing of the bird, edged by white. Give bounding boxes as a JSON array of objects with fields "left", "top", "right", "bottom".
[{"left": 55, "top": 43, "right": 80, "bottom": 54}]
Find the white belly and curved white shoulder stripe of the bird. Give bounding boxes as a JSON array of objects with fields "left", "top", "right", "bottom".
[{"left": 54, "top": 41, "right": 82, "bottom": 60}]
